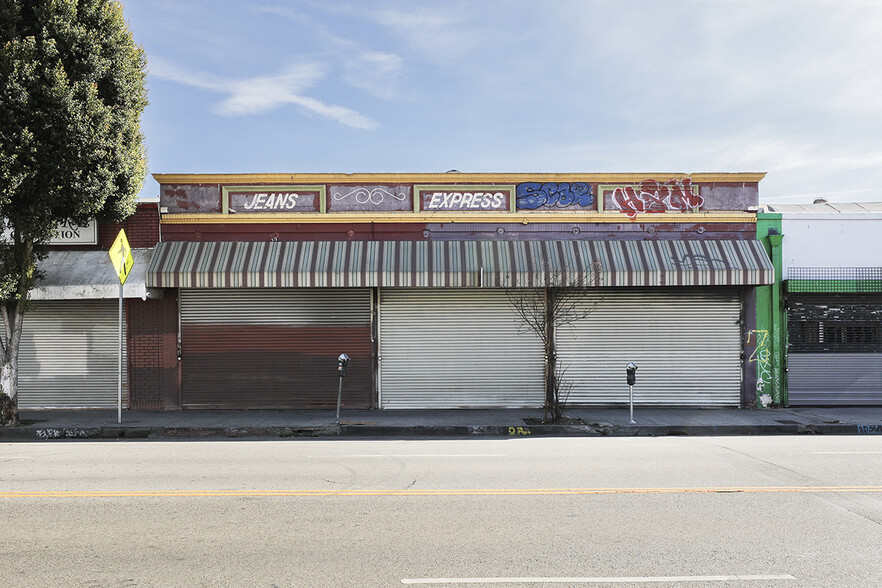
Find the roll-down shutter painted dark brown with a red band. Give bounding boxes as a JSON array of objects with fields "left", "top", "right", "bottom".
[{"left": 180, "top": 288, "right": 372, "bottom": 408}]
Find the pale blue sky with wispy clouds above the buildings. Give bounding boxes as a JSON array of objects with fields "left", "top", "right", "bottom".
[{"left": 123, "top": 0, "right": 882, "bottom": 204}]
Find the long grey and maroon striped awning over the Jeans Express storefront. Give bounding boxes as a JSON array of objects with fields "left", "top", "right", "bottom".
[{"left": 147, "top": 241, "right": 774, "bottom": 288}]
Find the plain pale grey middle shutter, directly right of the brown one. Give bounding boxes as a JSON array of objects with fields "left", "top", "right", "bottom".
[{"left": 380, "top": 289, "right": 545, "bottom": 408}]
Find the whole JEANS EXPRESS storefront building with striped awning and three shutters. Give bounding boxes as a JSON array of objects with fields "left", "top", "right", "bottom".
[{"left": 146, "top": 172, "right": 774, "bottom": 409}]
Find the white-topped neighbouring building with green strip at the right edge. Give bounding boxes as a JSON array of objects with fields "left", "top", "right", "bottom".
[{"left": 760, "top": 202, "right": 882, "bottom": 406}]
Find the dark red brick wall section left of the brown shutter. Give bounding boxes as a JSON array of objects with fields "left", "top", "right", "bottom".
[{"left": 126, "top": 292, "right": 179, "bottom": 410}]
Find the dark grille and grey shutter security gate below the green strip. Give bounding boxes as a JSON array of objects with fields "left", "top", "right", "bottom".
[{"left": 787, "top": 294, "right": 882, "bottom": 406}]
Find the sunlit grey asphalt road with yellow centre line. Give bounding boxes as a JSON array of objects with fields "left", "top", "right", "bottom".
[{"left": 0, "top": 436, "right": 882, "bottom": 588}]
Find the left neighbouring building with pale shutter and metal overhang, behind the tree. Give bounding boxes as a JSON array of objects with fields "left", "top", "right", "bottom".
[{"left": 10, "top": 201, "right": 168, "bottom": 409}]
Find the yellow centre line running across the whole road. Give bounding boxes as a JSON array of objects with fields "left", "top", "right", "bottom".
[{"left": 0, "top": 486, "right": 882, "bottom": 498}]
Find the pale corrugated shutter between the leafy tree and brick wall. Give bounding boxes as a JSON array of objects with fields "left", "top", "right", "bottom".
[{"left": 18, "top": 300, "right": 128, "bottom": 408}]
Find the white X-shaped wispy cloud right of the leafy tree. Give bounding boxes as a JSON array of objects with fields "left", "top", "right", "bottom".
[{"left": 150, "top": 57, "right": 378, "bottom": 130}]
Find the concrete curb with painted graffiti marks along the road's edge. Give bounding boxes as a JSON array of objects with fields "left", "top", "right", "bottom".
[{"left": 0, "top": 423, "right": 882, "bottom": 442}]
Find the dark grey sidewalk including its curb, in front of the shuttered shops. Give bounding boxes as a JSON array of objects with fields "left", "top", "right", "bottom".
[{"left": 0, "top": 406, "right": 882, "bottom": 442}]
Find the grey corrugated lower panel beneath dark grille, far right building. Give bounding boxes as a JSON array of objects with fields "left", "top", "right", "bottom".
[{"left": 787, "top": 353, "right": 882, "bottom": 406}]
